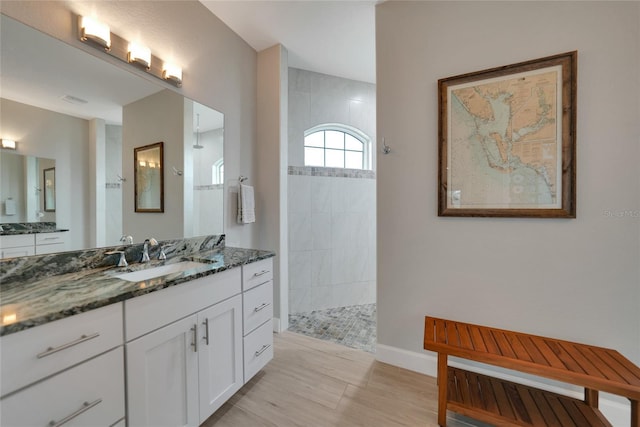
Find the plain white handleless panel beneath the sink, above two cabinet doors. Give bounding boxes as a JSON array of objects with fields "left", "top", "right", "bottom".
[{"left": 124, "top": 268, "right": 241, "bottom": 341}]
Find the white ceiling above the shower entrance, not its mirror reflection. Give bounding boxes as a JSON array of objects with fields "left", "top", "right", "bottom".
[{"left": 200, "top": 0, "right": 379, "bottom": 83}]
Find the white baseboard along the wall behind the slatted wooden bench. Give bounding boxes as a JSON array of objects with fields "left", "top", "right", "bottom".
[{"left": 376, "top": 344, "right": 631, "bottom": 426}]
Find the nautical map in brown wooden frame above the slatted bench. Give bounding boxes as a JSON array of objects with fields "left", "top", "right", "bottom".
[{"left": 438, "top": 51, "right": 577, "bottom": 218}]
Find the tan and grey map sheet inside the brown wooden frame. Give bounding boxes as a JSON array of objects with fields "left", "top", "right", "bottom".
[{"left": 447, "top": 66, "right": 562, "bottom": 209}]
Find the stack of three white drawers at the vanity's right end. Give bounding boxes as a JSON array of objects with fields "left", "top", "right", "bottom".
[{"left": 242, "top": 258, "right": 273, "bottom": 384}]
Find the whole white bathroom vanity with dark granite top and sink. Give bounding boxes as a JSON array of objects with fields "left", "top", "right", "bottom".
[{"left": 0, "top": 237, "right": 274, "bottom": 426}]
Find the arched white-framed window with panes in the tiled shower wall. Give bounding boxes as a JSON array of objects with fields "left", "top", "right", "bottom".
[{"left": 304, "top": 123, "right": 371, "bottom": 169}]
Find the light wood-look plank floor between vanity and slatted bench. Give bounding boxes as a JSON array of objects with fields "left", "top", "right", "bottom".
[{"left": 203, "top": 332, "right": 482, "bottom": 427}]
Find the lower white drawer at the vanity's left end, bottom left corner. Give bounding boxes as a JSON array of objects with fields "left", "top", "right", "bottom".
[{"left": 0, "top": 347, "right": 125, "bottom": 427}]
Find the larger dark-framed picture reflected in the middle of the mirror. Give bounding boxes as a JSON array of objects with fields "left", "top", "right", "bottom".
[{"left": 133, "top": 142, "right": 164, "bottom": 212}]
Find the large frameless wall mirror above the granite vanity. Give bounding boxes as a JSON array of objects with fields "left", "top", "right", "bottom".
[{"left": 0, "top": 15, "right": 224, "bottom": 258}]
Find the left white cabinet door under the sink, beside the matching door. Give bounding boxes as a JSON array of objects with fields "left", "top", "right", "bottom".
[{"left": 127, "top": 315, "right": 200, "bottom": 427}]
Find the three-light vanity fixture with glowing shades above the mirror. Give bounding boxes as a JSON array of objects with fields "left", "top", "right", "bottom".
[{"left": 78, "top": 16, "right": 182, "bottom": 87}]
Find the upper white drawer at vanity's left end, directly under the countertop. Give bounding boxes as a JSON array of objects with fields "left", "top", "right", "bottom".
[{"left": 0, "top": 303, "right": 123, "bottom": 396}]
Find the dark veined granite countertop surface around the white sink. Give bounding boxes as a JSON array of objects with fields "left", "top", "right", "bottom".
[{"left": 0, "top": 247, "right": 275, "bottom": 336}]
